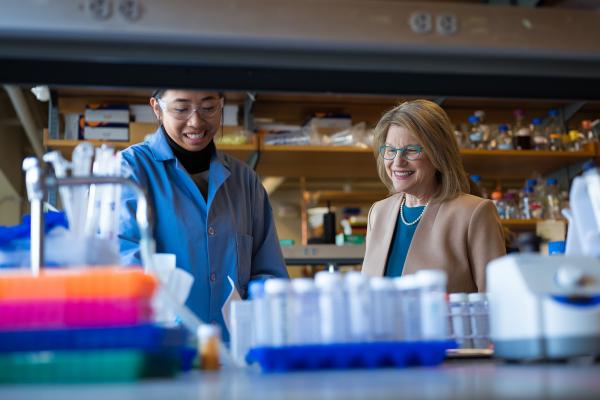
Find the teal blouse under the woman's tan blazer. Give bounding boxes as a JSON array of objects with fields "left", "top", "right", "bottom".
[{"left": 385, "top": 205, "right": 425, "bottom": 277}]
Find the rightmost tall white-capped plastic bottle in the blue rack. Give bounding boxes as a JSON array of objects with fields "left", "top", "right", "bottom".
[{"left": 416, "top": 269, "right": 448, "bottom": 340}]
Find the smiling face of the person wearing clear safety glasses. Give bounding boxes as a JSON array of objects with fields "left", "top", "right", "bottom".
[{"left": 150, "top": 90, "right": 223, "bottom": 151}]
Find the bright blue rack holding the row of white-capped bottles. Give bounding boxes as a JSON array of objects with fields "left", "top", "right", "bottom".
[{"left": 246, "top": 340, "right": 456, "bottom": 372}]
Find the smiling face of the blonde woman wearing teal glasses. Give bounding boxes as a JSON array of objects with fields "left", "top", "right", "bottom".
[{"left": 384, "top": 125, "right": 437, "bottom": 206}]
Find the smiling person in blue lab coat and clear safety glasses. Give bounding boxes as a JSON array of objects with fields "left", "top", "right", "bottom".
[{"left": 119, "top": 89, "right": 288, "bottom": 332}]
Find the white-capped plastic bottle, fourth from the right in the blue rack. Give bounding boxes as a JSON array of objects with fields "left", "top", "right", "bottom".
[{"left": 344, "top": 271, "right": 372, "bottom": 342}]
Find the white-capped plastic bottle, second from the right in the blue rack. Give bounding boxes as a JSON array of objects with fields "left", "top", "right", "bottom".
[{"left": 393, "top": 275, "right": 421, "bottom": 341}]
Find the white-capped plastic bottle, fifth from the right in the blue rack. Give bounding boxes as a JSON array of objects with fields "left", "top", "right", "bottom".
[{"left": 315, "top": 271, "right": 348, "bottom": 343}]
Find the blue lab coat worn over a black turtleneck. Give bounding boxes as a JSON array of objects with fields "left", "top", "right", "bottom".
[{"left": 119, "top": 127, "right": 288, "bottom": 332}]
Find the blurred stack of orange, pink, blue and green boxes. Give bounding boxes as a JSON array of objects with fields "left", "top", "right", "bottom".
[{"left": 0, "top": 267, "right": 189, "bottom": 383}]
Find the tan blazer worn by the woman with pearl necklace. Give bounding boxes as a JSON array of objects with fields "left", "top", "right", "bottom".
[{"left": 362, "top": 193, "right": 506, "bottom": 293}]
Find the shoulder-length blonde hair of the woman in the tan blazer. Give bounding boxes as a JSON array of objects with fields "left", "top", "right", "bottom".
[{"left": 373, "top": 100, "right": 469, "bottom": 201}]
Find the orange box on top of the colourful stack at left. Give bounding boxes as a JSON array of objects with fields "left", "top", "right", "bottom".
[{"left": 0, "top": 267, "right": 157, "bottom": 301}]
